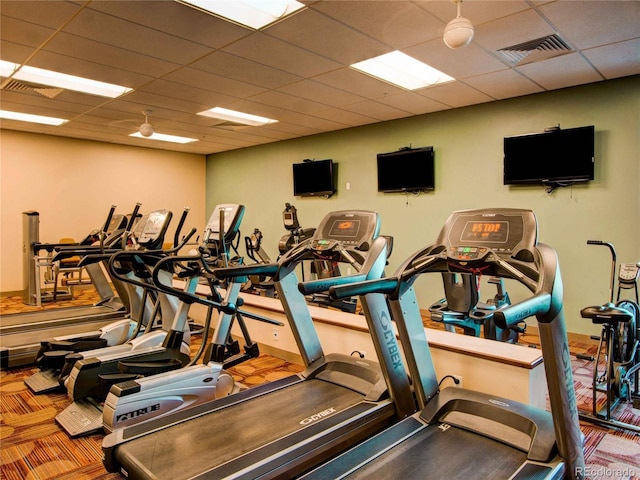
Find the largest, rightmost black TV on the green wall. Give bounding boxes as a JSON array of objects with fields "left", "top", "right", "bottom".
[{"left": 504, "top": 125, "right": 595, "bottom": 186}]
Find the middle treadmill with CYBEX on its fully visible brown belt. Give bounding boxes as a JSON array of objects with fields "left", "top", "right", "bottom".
[{"left": 103, "top": 210, "right": 416, "bottom": 480}]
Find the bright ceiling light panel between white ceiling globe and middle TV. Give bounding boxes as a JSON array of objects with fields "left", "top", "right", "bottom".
[{"left": 351, "top": 50, "right": 455, "bottom": 90}]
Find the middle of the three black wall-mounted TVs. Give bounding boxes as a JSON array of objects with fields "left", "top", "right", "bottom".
[{"left": 378, "top": 147, "right": 435, "bottom": 192}]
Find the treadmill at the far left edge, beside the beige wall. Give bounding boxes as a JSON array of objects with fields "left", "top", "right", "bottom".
[{"left": 0, "top": 206, "right": 135, "bottom": 370}]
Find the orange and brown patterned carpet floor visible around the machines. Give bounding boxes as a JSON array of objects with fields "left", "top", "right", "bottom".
[{"left": 0, "top": 289, "right": 640, "bottom": 480}]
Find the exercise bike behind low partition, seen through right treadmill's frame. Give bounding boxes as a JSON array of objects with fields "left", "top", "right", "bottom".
[{"left": 429, "top": 272, "right": 527, "bottom": 343}]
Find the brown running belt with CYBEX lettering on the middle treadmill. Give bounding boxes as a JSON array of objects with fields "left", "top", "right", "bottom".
[{"left": 115, "top": 379, "right": 370, "bottom": 480}]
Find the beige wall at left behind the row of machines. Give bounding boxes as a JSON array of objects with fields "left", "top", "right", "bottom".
[{"left": 0, "top": 130, "right": 206, "bottom": 292}]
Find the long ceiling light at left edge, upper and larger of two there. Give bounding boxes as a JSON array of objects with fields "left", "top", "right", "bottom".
[{"left": 0, "top": 60, "right": 133, "bottom": 98}]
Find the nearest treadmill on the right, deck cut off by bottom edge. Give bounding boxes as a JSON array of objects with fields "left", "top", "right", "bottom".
[{"left": 303, "top": 209, "right": 585, "bottom": 480}]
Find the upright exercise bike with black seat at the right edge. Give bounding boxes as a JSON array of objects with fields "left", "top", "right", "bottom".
[{"left": 579, "top": 240, "right": 640, "bottom": 433}]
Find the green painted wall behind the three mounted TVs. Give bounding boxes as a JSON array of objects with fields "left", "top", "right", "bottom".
[{"left": 206, "top": 76, "right": 640, "bottom": 334}]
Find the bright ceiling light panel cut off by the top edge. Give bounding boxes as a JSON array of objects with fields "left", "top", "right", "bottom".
[{"left": 178, "top": 0, "right": 304, "bottom": 30}]
